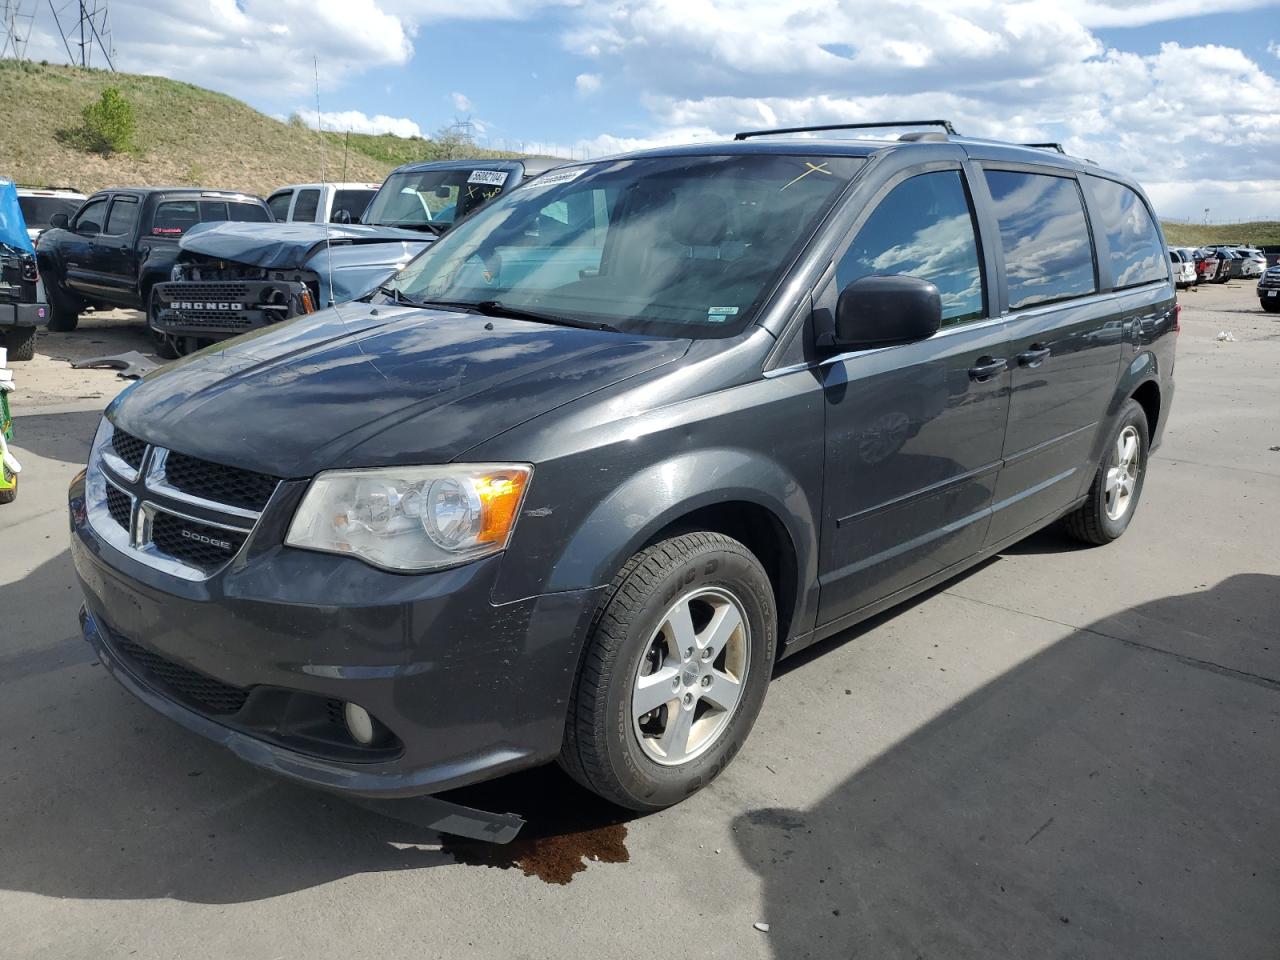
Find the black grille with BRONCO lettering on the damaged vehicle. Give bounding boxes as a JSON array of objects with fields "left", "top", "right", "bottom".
[{"left": 151, "top": 280, "right": 311, "bottom": 337}]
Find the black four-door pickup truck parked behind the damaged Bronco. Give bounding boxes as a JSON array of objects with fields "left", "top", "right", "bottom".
[{"left": 36, "top": 187, "right": 271, "bottom": 330}]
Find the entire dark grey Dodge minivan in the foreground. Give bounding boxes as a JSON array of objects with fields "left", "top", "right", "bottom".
[{"left": 70, "top": 122, "right": 1178, "bottom": 829}]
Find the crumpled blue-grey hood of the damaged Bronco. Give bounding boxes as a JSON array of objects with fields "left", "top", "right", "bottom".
[{"left": 178, "top": 220, "right": 435, "bottom": 270}]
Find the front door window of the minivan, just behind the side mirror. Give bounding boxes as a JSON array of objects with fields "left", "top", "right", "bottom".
[{"left": 836, "top": 170, "right": 986, "bottom": 326}]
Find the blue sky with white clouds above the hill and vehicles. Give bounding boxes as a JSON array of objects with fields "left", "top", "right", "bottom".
[{"left": 27, "top": 0, "right": 1280, "bottom": 221}]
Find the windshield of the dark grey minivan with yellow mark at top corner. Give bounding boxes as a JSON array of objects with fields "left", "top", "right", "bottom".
[{"left": 390, "top": 154, "right": 864, "bottom": 338}]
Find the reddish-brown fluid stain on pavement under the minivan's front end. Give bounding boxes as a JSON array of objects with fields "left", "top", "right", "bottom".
[{"left": 440, "top": 767, "right": 636, "bottom": 886}]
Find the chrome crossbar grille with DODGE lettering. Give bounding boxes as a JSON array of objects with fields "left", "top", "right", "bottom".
[{"left": 86, "top": 421, "right": 280, "bottom": 580}]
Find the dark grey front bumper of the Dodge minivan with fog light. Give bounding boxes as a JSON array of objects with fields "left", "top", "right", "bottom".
[{"left": 70, "top": 476, "right": 599, "bottom": 803}]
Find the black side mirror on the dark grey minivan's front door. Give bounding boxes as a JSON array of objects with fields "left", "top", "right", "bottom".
[{"left": 835, "top": 275, "right": 942, "bottom": 348}]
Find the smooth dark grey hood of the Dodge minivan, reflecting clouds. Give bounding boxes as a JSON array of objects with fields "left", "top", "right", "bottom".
[{"left": 108, "top": 303, "right": 690, "bottom": 477}]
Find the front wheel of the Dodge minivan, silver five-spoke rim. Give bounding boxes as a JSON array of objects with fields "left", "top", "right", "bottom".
[{"left": 559, "top": 532, "right": 777, "bottom": 812}]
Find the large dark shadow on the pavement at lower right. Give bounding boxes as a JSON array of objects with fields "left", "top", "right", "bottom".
[{"left": 735, "top": 575, "right": 1280, "bottom": 960}]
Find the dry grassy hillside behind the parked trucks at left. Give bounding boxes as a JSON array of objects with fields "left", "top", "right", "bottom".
[{"left": 0, "top": 60, "right": 524, "bottom": 196}]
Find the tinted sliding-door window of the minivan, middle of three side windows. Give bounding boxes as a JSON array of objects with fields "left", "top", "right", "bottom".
[{"left": 987, "top": 170, "right": 1098, "bottom": 310}]
